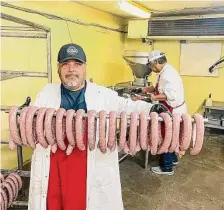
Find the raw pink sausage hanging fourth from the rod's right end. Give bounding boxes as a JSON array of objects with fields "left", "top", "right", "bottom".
[{"left": 157, "top": 113, "right": 172, "bottom": 154}]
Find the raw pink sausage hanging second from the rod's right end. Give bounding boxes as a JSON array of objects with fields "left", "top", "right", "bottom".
[{"left": 180, "top": 114, "right": 192, "bottom": 151}]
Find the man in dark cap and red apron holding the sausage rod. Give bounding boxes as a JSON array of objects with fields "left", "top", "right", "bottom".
[{"left": 28, "top": 44, "right": 169, "bottom": 210}]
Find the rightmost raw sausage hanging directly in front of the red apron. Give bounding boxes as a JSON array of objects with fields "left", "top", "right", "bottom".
[{"left": 75, "top": 109, "right": 85, "bottom": 151}]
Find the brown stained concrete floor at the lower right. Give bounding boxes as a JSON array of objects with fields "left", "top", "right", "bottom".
[{"left": 120, "top": 130, "right": 224, "bottom": 210}]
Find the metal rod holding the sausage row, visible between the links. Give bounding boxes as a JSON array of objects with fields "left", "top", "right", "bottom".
[{"left": 1, "top": 106, "right": 208, "bottom": 123}]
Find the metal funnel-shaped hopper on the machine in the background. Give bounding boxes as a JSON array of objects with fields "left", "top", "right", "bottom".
[{"left": 123, "top": 51, "right": 152, "bottom": 79}]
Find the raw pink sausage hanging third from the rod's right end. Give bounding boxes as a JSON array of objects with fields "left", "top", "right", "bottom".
[{"left": 169, "top": 114, "right": 181, "bottom": 153}]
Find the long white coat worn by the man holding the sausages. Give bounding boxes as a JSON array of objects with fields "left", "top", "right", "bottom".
[{"left": 28, "top": 81, "right": 152, "bottom": 210}]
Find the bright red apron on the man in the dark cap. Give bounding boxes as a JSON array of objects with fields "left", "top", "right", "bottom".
[{"left": 47, "top": 122, "right": 87, "bottom": 210}]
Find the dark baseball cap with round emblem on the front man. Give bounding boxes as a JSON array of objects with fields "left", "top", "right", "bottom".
[{"left": 58, "top": 43, "right": 86, "bottom": 63}]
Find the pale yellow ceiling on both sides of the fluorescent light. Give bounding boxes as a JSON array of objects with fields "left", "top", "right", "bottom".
[{"left": 72, "top": 0, "right": 224, "bottom": 18}]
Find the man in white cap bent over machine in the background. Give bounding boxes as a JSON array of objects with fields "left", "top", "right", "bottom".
[{"left": 142, "top": 50, "right": 187, "bottom": 175}]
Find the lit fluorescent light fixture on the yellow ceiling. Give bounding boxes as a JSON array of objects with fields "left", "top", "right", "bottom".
[{"left": 118, "top": 0, "right": 151, "bottom": 18}]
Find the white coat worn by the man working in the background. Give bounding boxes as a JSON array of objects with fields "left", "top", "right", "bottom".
[{"left": 157, "top": 64, "right": 187, "bottom": 114}]
